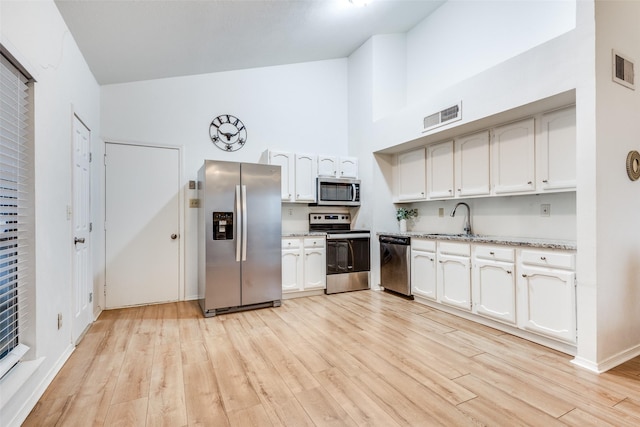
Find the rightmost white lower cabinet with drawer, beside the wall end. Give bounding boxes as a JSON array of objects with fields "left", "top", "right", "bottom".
[{"left": 518, "top": 250, "right": 576, "bottom": 343}]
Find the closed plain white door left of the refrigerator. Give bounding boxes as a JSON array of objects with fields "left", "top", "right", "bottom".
[{"left": 105, "top": 143, "right": 180, "bottom": 308}]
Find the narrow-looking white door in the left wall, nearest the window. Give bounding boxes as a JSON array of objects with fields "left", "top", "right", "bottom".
[{"left": 71, "top": 116, "right": 93, "bottom": 342}]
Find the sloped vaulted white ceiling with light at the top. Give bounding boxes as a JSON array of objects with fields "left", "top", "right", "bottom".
[{"left": 55, "top": 0, "right": 444, "bottom": 84}]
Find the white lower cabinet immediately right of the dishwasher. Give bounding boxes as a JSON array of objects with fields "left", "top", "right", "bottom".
[{"left": 411, "top": 239, "right": 438, "bottom": 301}]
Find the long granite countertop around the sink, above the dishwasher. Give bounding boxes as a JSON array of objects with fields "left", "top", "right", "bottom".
[{"left": 376, "top": 231, "right": 577, "bottom": 251}]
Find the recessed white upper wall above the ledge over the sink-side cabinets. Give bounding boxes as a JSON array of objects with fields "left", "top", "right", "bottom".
[{"left": 407, "top": 0, "right": 576, "bottom": 103}]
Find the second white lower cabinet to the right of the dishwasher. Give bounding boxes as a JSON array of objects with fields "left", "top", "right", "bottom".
[{"left": 437, "top": 242, "right": 471, "bottom": 311}]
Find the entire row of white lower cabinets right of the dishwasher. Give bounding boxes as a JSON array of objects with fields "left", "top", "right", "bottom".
[{"left": 411, "top": 238, "right": 576, "bottom": 345}]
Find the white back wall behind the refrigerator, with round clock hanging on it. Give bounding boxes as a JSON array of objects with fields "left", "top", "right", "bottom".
[{"left": 102, "top": 59, "right": 348, "bottom": 299}]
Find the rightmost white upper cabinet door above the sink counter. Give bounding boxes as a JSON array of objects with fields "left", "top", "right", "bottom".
[{"left": 536, "top": 107, "right": 576, "bottom": 191}]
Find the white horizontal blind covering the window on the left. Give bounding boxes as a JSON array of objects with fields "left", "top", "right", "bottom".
[{"left": 0, "top": 54, "right": 32, "bottom": 377}]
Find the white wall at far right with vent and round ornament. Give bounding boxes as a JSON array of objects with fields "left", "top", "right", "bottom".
[{"left": 595, "top": 1, "right": 640, "bottom": 372}]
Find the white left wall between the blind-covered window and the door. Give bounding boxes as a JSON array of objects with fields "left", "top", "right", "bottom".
[{"left": 0, "top": 1, "right": 100, "bottom": 426}]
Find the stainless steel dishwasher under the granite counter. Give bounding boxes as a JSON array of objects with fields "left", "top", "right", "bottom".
[{"left": 378, "top": 235, "right": 413, "bottom": 299}]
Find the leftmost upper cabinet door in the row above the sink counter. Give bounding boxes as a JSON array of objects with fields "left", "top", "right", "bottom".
[{"left": 396, "top": 148, "right": 426, "bottom": 201}]
